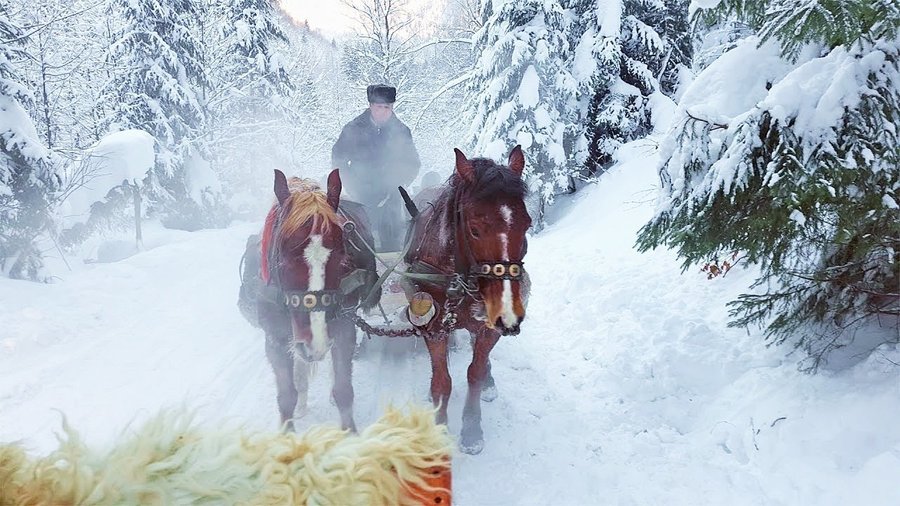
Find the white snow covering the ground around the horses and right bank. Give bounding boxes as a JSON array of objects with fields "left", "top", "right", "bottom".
[{"left": 0, "top": 139, "right": 900, "bottom": 506}]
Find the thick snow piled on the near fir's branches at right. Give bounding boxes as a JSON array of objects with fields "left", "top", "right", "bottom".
[{"left": 658, "top": 37, "right": 900, "bottom": 220}]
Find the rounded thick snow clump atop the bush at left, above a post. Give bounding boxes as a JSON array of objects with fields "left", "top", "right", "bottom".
[{"left": 60, "top": 130, "right": 156, "bottom": 225}]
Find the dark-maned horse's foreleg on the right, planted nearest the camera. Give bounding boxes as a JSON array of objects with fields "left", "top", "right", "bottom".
[{"left": 459, "top": 327, "right": 500, "bottom": 455}]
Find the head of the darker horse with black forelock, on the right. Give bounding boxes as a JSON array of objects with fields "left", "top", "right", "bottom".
[{"left": 451, "top": 146, "right": 531, "bottom": 335}]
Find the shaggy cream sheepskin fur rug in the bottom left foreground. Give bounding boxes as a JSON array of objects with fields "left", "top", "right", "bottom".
[{"left": 0, "top": 408, "right": 452, "bottom": 506}]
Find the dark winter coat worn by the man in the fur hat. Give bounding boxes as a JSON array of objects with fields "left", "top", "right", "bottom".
[{"left": 331, "top": 109, "right": 421, "bottom": 205}]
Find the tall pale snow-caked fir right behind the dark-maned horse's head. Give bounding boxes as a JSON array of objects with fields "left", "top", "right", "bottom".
[{"left": 467, "top": 0, "right": 576, "bottom": 226}]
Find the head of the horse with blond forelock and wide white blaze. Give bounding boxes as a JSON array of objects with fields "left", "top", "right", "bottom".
[{"left": 271, "top": 169, "right": 346, "bottom": 361}]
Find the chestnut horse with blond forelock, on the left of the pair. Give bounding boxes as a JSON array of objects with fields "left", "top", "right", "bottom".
[{"left": 245, "top": 169, "right": 377, "bottom": 431}]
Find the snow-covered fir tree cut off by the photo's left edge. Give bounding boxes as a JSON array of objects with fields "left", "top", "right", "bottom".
[{"left": 0, "top": 1, "right": 59, "bottom": 279}]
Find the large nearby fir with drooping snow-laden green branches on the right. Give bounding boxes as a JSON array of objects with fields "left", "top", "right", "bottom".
[{"left": 639, "top": 0, "right": 900, "bottom": 369}]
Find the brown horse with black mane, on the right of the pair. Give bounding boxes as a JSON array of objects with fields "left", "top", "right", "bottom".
[{"left": 405, "top": 146, "right": 531, "bottom": 454}]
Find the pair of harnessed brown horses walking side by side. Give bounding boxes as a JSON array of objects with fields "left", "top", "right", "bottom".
[{"left": 243, "top": 146, "right": 531, "bottom": 453}]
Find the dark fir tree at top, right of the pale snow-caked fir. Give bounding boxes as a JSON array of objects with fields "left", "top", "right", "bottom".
[{"left": 570, "top": 0, "right": 691, "bottom": 176}]
